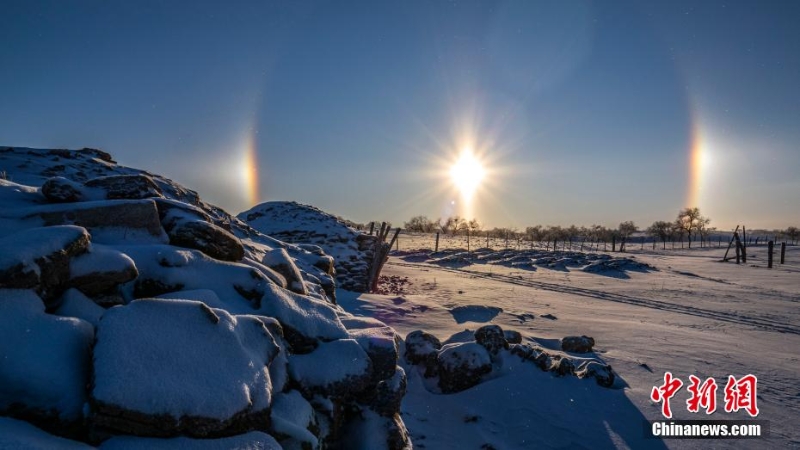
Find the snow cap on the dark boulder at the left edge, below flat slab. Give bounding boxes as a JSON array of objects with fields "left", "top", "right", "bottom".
[{"left": 0, "top": 225, "right": 89, "bottom": 273}]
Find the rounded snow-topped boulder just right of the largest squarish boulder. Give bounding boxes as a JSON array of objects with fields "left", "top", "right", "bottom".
[{"left": 289, "top": 339, "right": 372, "bottom": 399}]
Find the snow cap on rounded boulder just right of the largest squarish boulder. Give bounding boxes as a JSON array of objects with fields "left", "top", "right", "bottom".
[{"left": 289, "top": 339, "right": 370, "bottom": 388}]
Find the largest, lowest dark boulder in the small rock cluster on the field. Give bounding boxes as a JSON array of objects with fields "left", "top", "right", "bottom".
[{"left": 437, "top": 342, "right": 492, "bottom": 393}]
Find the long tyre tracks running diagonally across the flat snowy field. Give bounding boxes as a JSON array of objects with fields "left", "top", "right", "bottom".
[{"left": 389, "top": 261, "right": 800, "bottom": 335}]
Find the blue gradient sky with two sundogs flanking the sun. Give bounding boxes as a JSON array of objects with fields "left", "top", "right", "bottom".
[{"left": 0, "top": 0, "right": 800, "bottom": 229}]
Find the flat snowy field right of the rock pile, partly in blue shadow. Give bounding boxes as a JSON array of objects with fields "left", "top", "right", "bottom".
[{"left": 339, "top": 244, "right": 800, "bottom": 449}]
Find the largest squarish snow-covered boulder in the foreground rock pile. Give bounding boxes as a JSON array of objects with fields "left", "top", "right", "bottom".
[{"left": 91, "top": 299, "right": 279, "bottom": 437}]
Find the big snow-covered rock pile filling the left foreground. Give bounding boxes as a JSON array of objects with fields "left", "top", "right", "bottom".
[{"left": 0, "top": 147, "right": 410, "bottom": 449}]
